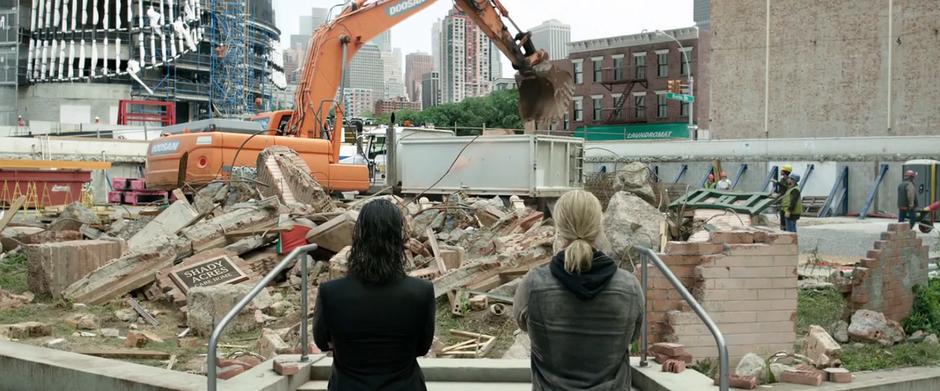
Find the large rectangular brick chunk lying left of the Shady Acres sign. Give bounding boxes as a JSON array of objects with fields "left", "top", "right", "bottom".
[{"left": 26, "top": 240, "right": 123, "bottom": 298}]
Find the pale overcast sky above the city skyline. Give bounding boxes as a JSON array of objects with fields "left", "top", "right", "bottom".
[{"left": 274, "top": 0, "right": 694, "bottom": 77}]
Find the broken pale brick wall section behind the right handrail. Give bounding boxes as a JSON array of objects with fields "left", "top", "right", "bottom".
[{"left": 647, "top": 228, "right": 799, "bottom": 362}]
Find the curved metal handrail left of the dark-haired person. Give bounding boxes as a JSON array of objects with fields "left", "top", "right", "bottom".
[{"left": 206, "top": 244, "right": 317, "bottom": 391}]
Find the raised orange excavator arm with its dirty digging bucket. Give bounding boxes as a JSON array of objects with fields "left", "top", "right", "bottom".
[{"left": 286, "top": 0, "right": 574, "bottom": 158}]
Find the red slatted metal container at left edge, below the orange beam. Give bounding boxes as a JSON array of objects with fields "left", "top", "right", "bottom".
[{"left": 0, "top": 169, "right": 91, "bottom": 208}]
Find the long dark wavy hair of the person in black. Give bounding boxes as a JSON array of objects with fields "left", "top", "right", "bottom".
[{"left": 349, "top": 199, "right": 405, "bottom": 284}]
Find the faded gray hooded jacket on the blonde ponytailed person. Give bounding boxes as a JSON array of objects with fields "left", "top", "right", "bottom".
[{"left": 513, "top": 251, "right": 643, "bottom": 391}]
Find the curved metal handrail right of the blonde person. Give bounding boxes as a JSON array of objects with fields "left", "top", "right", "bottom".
[{"left": 633, "top": 246, "right": 730, "bottom": 391}]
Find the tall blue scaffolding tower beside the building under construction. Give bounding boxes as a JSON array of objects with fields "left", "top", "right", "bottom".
[{"left": 209, "top": 0, "right": 252, "bottom": 118}]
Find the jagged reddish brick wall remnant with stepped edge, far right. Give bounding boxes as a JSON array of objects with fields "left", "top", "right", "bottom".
[{"left": 848, "top": 223, "right": 929, "bottom": 322}]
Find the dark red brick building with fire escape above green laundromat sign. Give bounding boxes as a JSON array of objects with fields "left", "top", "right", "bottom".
[{"left": 555, "top": 27, "right": 700, "bottom": 140}]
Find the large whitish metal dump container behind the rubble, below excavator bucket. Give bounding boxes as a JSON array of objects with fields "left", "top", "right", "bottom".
[{"left": 397, "top": 135, "right": 584, "bottom": 198}]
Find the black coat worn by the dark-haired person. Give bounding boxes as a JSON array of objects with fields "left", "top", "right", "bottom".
[{"left": 313, "top": 277, "right": 435, "bottom": 391}]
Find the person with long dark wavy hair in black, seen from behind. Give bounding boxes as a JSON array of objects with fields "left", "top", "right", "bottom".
[{"left": 313, "top": 199, "right": 435, "bottom": 391}]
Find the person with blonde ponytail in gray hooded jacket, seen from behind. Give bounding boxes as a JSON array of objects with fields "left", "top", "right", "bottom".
[{"left": 513, "top": 190, "right": 643, "bottom": 391}]
